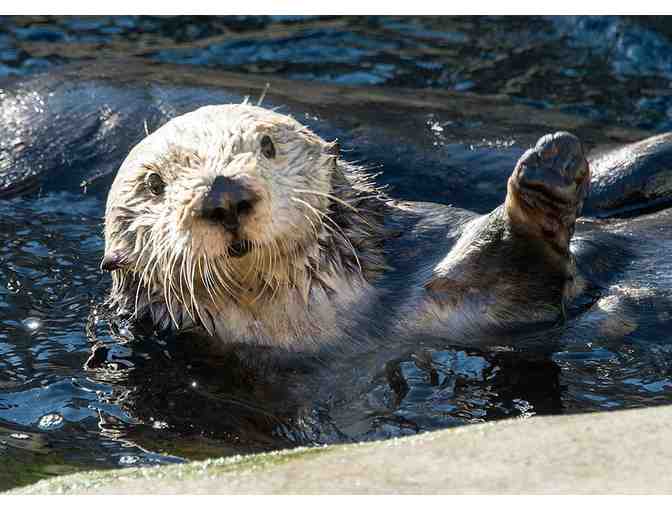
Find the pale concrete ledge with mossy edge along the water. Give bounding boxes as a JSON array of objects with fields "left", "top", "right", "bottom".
[{"left": 6, "top": 406, "right": 672, "bottom": 494}]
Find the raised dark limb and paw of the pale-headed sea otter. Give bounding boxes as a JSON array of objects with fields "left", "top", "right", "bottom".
[{"left": 425, "top": 132, "right": 590, "bottom": 331}]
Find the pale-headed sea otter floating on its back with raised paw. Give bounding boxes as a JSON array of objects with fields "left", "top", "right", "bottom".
[{"left": 101, "top": 104, "right": 608, "bottom": 351}]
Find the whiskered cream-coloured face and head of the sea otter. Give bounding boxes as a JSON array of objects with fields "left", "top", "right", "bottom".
[{"left": 101, "top": 104, "right": 352, "bottom": 332}]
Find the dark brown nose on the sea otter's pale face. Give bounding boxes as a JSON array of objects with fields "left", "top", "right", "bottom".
[{"left": 201, "top": 175, "right": 257, "bottom": 232}]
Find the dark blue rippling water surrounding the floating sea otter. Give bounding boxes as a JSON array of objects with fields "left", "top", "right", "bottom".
[{"left": 0, "top": 17, "right": 672, "bottom": 489}]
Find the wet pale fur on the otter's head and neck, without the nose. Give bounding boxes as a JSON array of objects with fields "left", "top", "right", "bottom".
[{"left": 102, "top": 104, "right": 384, "bottom": 343}]
